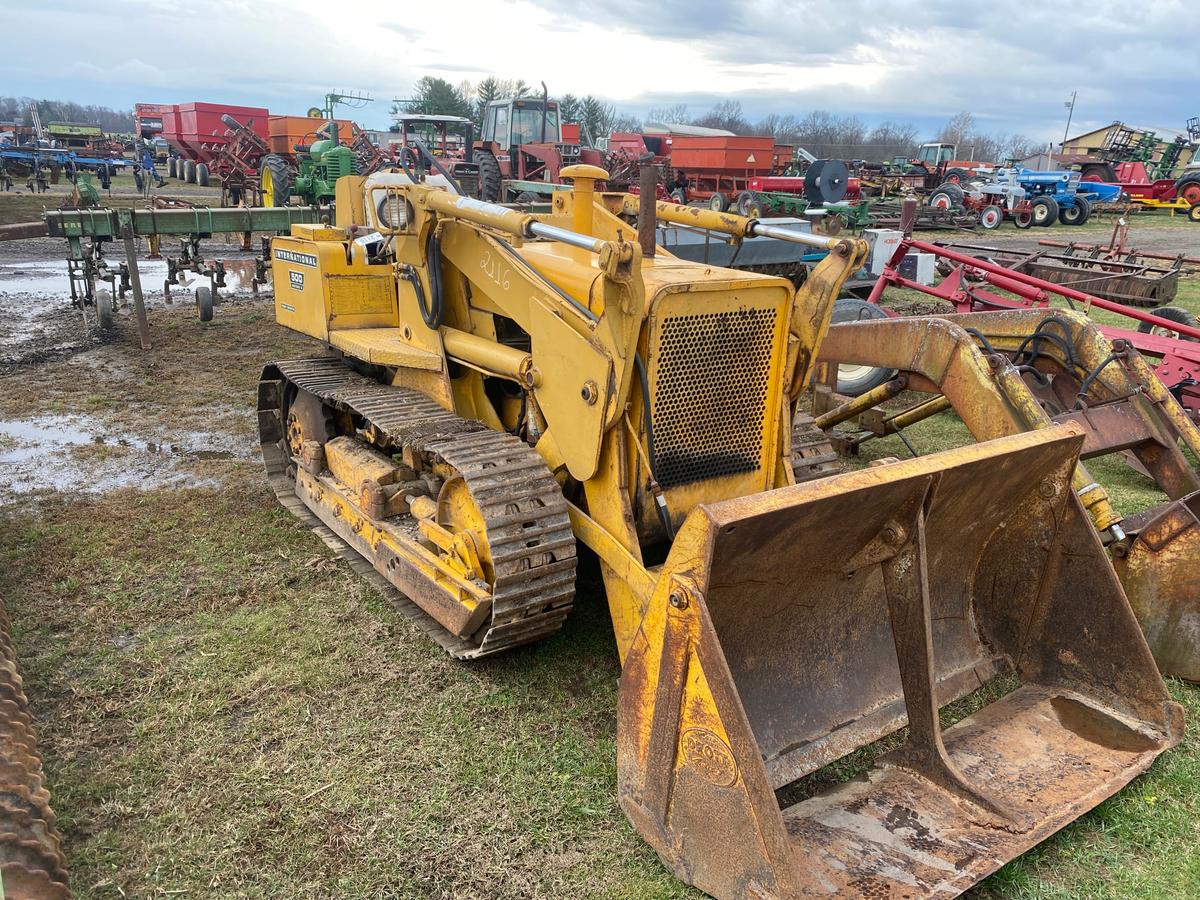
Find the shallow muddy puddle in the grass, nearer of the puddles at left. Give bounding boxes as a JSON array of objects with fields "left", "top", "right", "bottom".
[{"left": 0, "top": 415, "right": 251, "bottom": 493}]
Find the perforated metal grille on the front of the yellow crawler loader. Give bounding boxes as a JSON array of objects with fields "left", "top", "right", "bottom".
[{"left": 653, "top": 308, "right": 776, "bottom": 490}]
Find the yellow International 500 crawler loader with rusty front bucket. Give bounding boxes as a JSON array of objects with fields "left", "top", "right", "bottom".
[{"left": 258, "top": 161, "right": 1182, "bottom": 900}]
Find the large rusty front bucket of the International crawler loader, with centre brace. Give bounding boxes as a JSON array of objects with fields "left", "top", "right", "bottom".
[{"left": 618, "top": 426, "right": 1182, "bottom": 899}]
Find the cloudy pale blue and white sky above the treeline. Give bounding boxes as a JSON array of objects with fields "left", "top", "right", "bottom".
[{"left": 0, "top": 0, "right": 1200, "bottom": 140}]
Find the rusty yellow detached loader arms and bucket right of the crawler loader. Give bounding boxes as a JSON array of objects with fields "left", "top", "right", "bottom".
[{"left": 816, "top": 310, "right": 1200, "bottom": 682}]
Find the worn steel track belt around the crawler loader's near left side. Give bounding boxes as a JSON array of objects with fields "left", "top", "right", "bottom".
[{"left": 258, "top": 358, "right": 576, "bottom": 659}]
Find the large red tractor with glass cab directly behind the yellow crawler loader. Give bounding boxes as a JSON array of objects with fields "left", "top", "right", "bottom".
[{"left": 473, "top": 94, "right": 604, "bottom": 203}]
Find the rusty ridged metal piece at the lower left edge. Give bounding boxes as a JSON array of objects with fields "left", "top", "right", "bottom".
[{"left": 0, "top": 601, "right": 71, "bottom": 900}]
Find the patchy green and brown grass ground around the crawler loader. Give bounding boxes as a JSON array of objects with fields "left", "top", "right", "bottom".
[{"left": 0, "top": 200, "right": 1200, "bottom": 900}]
